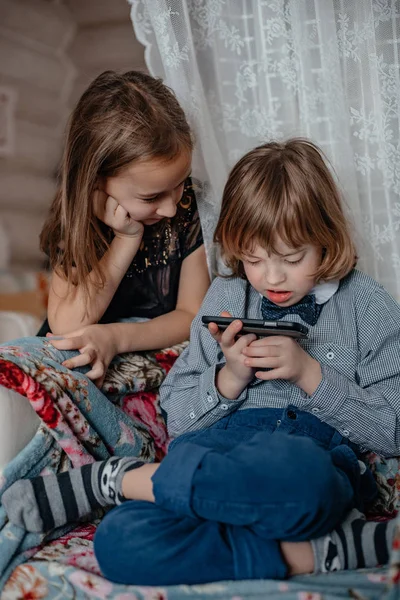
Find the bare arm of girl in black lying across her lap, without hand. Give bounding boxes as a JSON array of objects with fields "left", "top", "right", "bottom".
[{"left": 108, "top": 245, "right": 210, "bottom": 354}]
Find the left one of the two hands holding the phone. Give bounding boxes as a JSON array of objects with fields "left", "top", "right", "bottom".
[{"left": 208, "top": 311, "right": 257, "bottom": 395}]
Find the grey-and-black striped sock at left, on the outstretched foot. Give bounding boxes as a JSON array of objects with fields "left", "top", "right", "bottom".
[{"left": 1, "top": 456, "right": 143, "bottom": 532}]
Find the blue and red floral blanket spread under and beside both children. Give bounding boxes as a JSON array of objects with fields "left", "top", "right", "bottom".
[{"left": 0, "top": 338, "right": 400, "bottom": 600}]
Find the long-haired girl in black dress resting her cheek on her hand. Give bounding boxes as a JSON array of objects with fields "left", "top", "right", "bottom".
[{"left": 39, "top": 71, "right": 209, "bottom": 385}]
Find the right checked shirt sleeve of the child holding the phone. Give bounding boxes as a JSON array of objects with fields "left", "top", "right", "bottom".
[{"left": 299, "top": 288, "right": 400, "bottom": 456}]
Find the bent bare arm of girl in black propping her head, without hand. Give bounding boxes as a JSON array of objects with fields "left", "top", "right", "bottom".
[{"left": 48, "top": 234, "right": 142, "bottom": 335}]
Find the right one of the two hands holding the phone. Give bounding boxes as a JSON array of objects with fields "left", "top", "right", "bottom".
[{"left": 243, "top": 335, "right": 322, "bottom": 396}]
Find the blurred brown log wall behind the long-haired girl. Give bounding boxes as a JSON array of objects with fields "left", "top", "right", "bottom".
[{"left": 0, "top": 0, "right": 146, "bottom": 268}]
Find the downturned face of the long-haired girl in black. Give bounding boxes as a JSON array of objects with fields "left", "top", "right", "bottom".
[{"left": 104, "top": 152, "right": 192, "bottom": 225}]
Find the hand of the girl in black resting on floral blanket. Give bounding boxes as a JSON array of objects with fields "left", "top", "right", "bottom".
[{"left": 47, "top": 325, "right": 118, "bottom": 388}]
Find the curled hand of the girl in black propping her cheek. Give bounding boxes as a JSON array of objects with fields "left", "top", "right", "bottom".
[{"left": 93, "top": 189, "right": 144, "bottom": 238}]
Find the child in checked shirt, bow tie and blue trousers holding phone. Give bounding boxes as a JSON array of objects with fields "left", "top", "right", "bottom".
[{"left": 3, "top": 139, "right": 400, "bottom": 585}]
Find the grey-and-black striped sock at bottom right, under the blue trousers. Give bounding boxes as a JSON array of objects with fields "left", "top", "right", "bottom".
[{"left": 311, "top": 509, "right": 396, "bottom": 573}]
